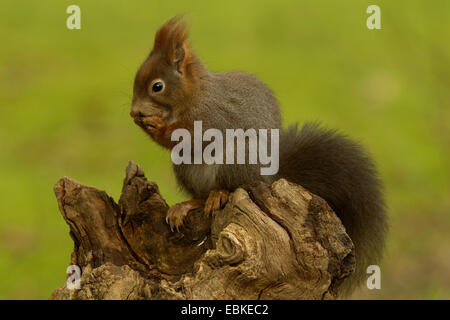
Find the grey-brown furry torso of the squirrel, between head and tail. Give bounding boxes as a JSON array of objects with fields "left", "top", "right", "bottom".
[{"left": 173, "top": 72, "right": 281, "bottom": 199}]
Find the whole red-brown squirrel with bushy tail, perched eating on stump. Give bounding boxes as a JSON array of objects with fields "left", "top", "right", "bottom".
[{"left": 130, "top": 16, "right": 387, "bottom": 296}]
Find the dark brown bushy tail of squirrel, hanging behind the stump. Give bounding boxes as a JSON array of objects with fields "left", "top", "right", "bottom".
[{"left": 276, "top": 123, "right": 387, "bottom": 298}]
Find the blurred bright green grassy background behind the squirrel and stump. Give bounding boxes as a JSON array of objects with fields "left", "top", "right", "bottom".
[{"left": 0, "top": 0, "right": 450, "bottom": 299}]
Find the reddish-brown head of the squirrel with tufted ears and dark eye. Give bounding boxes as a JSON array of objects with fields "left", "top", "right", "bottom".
[{"left": 130, "top": 16, "right": 206, "bottom": 122}]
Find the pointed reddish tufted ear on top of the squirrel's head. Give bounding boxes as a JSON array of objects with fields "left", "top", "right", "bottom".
[{"left": 153, "top": 16, "right": 190, "bottom": 73}]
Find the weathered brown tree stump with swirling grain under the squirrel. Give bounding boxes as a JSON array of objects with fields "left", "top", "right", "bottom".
[{"left": 51, "top": 162, "right": 355, "bottom": 299}]
